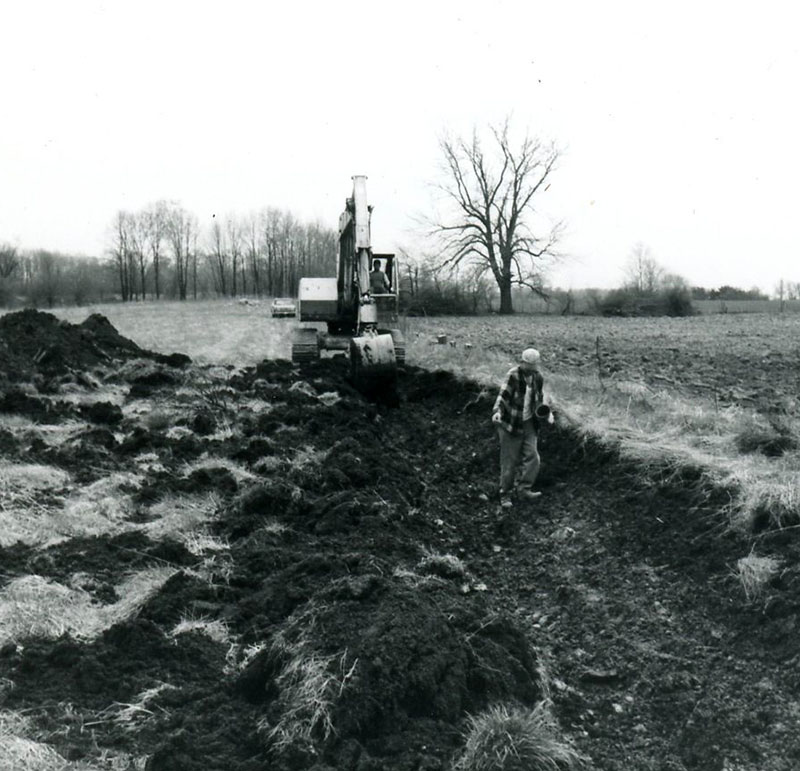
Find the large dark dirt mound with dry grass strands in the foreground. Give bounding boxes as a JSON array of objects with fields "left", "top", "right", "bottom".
[{"left": 239, "top": 584, "right": 541, "bottom": 768}]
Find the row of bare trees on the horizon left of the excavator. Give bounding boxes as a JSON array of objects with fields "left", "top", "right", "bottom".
[{"left": 0, "top": 208, "right": 337, "bottom": 308}]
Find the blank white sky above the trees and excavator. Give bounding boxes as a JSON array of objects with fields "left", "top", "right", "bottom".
[{"left": 0, "top": 0, "right": 800, "bottom": 291}]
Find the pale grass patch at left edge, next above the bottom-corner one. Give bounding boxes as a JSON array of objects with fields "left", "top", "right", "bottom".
[{"left": 0, "top": 568, "right": 177, "bottom": 645}]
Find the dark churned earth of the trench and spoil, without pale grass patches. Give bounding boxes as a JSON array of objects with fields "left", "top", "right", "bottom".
[{"left": 0, "top": 311, "right": 800, "bottom": 771}]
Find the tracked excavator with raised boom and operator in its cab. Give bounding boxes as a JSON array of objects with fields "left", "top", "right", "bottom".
[{"left": 292, "top": 176, "right": 405, "bottom": 390}]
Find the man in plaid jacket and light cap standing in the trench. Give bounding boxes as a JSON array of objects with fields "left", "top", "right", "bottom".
[{"left": 492, "top": 348, "right": 544, "bottom": 508}]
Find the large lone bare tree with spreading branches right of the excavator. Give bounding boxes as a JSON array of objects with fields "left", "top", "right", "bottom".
[{"left": 433, "top": 120, "right": 562, "bottom": 314}]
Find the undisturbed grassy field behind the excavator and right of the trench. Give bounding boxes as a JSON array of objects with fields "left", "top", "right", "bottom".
[{"left": 43, "top": 301, "right": 800, "bottom": 531}]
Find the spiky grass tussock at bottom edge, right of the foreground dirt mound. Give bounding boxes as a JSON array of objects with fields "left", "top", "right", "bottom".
[{"left": 453, "top": 702, "right": 582, "bottom": 771}]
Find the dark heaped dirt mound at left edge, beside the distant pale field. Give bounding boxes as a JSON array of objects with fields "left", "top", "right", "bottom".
[{"left": 0, "top": 309, "right": 190, "bottom": 382}]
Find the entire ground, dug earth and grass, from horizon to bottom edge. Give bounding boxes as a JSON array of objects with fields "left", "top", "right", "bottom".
[{"left": 0, "top": 303, "right": 800, "bottom": 771}]
